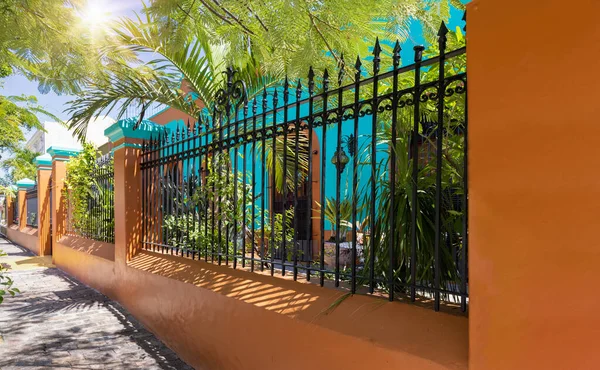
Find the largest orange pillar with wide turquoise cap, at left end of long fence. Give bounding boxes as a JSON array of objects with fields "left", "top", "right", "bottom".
[{"left": 104, "top": 119, "right": 165, "bottom": 264}]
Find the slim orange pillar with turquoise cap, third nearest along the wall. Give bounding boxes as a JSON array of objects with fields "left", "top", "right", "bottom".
[{"left": 34, "top": 154, "right": 52, "bottom": 256}]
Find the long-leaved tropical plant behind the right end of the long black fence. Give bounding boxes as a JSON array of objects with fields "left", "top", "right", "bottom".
[{"left": 360, "top": 29, "right": 466, "bottom": 292}]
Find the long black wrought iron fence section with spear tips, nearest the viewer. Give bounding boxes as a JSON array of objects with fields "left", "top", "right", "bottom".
[{"left": 141, "top": 21, "right": 468, "bottom": 310}]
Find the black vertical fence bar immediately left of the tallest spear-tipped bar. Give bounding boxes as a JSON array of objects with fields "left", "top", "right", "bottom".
[{"left": 410, "top": 45, "right": 425, "bottom": 302}]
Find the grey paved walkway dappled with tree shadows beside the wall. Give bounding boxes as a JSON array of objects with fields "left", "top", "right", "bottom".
[{"left": 0, "top": 238, "right": 191, "bottom": 370}]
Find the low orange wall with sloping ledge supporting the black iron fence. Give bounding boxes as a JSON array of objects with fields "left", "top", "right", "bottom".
[{"left": 54, "top": 236, "right": 468, "bottom": 370}]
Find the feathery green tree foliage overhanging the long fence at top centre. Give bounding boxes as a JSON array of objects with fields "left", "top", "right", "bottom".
[{"left": 149, "top": 0, "right": 464, "bottom": 78}]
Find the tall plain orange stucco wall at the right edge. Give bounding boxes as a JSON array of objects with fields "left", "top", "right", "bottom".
[{"left": 467, "top": 0, "right": 600, "bottom": 370}]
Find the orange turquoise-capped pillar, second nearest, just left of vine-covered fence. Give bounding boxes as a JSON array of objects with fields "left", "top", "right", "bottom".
[{"left": 48, "top": 147, "right": 80, "bottom": 260}]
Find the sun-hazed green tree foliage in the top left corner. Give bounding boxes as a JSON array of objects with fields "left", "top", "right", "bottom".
[{"left": 0, "top": 0, "right": 137, "bottom": 93}]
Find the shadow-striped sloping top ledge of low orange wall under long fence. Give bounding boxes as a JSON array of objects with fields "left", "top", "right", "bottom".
[{"left": 128, "top": 250, "right": 468, "bottom": 363}]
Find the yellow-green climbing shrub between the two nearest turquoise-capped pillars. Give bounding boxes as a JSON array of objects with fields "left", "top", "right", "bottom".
[{"left": 63, "top": 143, "right": 115, "bottom": 240}]
